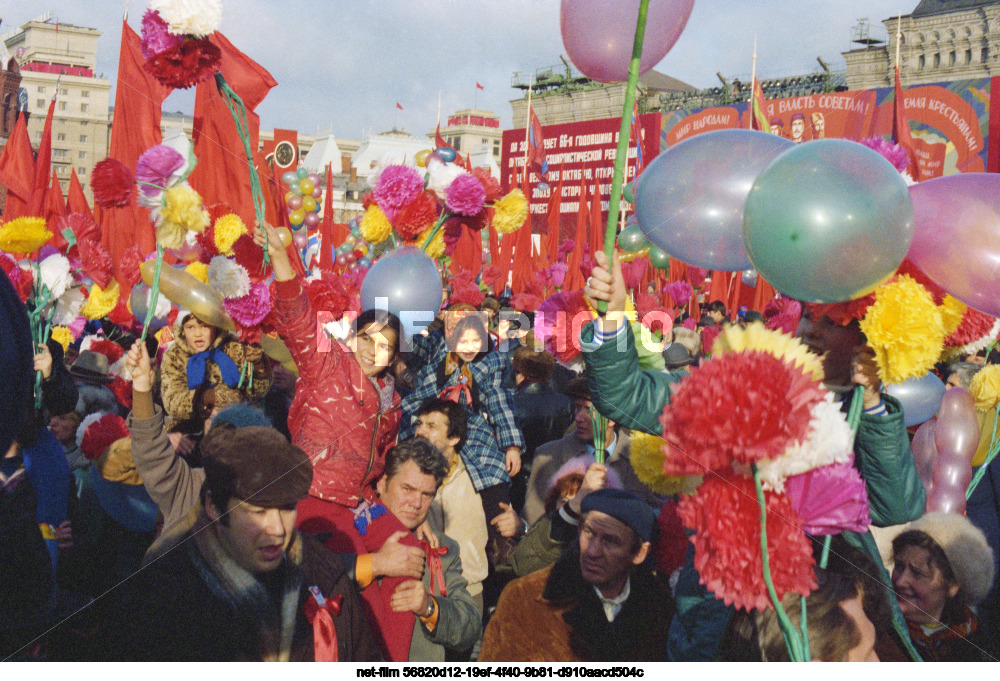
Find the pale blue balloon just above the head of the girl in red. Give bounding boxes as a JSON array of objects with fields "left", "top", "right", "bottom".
[{"left": 361, "top": 246, "right": 444, "bottom": 331}]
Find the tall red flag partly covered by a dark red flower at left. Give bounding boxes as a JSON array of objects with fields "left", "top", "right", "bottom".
[{"left": 94, "top": 19, "right": 171, "bottom": 270}]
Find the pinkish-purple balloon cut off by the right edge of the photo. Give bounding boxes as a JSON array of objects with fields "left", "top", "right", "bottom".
[{"left": 907, "top": 173, "right": 1000, "bottom": 317}]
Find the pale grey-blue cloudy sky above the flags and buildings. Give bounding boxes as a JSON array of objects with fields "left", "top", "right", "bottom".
[{"left": 0, "top": 0, "right": 917, "bottom": 139}]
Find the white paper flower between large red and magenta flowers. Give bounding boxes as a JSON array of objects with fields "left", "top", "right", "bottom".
[{"left": 757, "top": 392, "right": 854, "bottom": 492}]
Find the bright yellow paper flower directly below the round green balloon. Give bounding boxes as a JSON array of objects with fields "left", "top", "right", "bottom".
[{"left": 861, "top": 274, "right": 944, "bottom": 383}]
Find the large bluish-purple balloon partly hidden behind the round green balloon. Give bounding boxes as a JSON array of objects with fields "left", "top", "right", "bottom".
[{"left": 635, "top": 130, "right": 795, "bottom": 272}]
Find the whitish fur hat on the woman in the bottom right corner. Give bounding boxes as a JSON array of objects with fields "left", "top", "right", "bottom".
[{"left": 902, "top": 512, "right": 994, "bottom": 605}]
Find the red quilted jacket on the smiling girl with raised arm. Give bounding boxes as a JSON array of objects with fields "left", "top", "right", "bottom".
[{"left": 274, "top": 278, "right": 400, "bottom": 508}]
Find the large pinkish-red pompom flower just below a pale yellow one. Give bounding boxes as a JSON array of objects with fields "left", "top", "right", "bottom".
[{"left": 660, "top": 352, "right": 823, "bottom": 475}]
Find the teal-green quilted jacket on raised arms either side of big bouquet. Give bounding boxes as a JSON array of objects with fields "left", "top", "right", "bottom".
[{"left": 580, "top": 322, "right": 925, "bottom": 660}]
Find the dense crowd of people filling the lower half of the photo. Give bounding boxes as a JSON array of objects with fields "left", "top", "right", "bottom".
[{"left": 0, "top": 226, "right": 1000, "bottom": 662}]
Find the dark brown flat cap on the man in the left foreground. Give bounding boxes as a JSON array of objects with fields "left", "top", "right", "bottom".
[{"left": 201, "top": 425, "right": 313, "bottom": 508}]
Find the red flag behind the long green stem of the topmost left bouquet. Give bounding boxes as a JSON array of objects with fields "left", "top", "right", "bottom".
[{"left": 189, "top": 32, "right": 278, "bottom": 227}]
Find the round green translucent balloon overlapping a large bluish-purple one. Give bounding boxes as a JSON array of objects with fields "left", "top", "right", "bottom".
[{"left": 744, "top": 135, "right": 913, "bottom": 303}]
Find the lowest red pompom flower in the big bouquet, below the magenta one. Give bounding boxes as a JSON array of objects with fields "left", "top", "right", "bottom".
[{"left": 677, "top": 468, "right": 816, "bottom": 610}]
